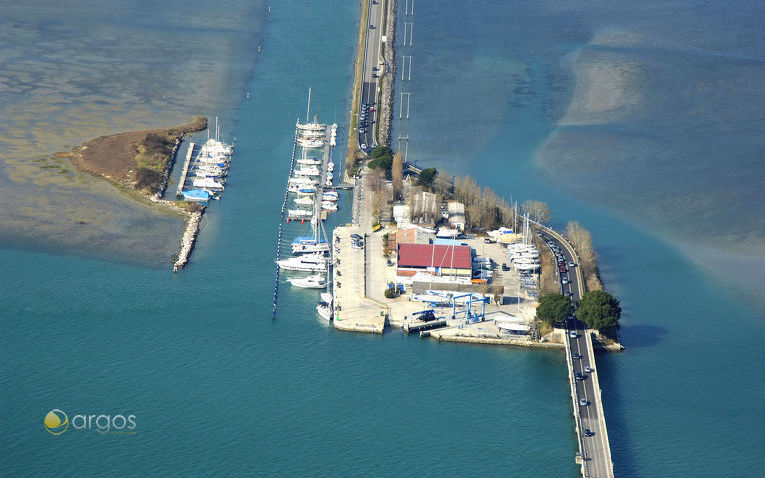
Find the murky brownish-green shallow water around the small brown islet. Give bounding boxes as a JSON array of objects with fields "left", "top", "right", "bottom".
[{"left": 0, "top": 2, "right": 263, "bottom": 264}]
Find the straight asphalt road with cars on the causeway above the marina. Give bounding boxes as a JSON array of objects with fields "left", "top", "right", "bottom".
[{"left": 356, "top": 0, "right": 384, "bottom": 148}]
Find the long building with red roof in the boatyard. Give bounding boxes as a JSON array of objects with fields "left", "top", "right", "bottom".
[{"left": 396, "top": 244, "right": 473, "bottom": 277}]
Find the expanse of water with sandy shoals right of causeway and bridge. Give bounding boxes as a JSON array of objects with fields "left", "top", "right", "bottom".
[{"left": 394, "top": 2, "right": 765, "bottom": 476}]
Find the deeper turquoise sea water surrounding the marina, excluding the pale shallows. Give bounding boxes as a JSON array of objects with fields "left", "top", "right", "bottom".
[{"left": 0, "top": 0, "right": 765, "bottom": 477}]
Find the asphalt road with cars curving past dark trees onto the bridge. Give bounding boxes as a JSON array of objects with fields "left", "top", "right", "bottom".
[{"left": 542, "top": 230, "right": 613, "bottom": 477}]
